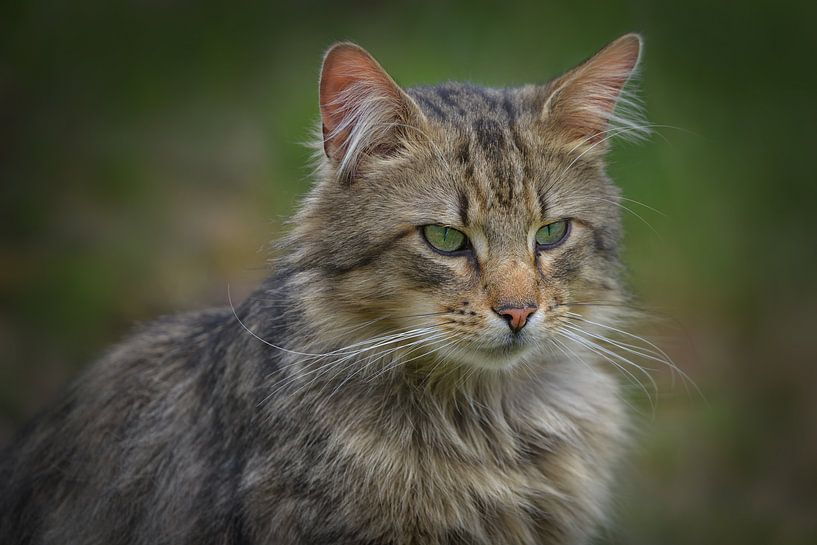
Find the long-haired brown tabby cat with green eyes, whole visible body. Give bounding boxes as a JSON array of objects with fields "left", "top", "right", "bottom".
[{"left": 0, "top": 34, "right": 643, "bottom": 545}]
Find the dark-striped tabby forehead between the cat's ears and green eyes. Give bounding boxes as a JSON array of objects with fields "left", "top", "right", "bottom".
[{"left": 407, "top": 83, "right": 588, "bottom": 231}]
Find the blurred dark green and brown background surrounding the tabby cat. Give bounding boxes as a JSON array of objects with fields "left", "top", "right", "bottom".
[{"left": 0, "top": 0, "right": 817, "bottom": 545}]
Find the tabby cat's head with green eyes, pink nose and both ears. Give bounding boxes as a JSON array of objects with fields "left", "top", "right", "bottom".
[{"left": 289, "top": 34, "right": 641, "bottom": 369}]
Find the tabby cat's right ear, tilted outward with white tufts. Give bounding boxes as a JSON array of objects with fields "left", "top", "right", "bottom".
[{"left": 542, "top": 34, "right": 648, "bottom": 152}]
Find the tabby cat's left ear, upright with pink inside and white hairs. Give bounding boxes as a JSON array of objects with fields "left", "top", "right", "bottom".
[{"left": 320, "top": 43, "right": 422, "bottom": 182}]
